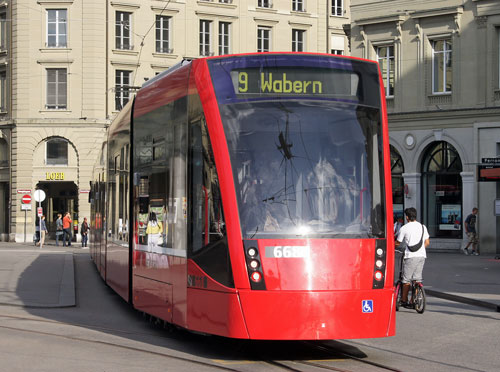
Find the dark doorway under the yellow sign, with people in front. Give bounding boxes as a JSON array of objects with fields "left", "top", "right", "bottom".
[{"left": 35, "top": 181, "right": 78, "bottom": 240}]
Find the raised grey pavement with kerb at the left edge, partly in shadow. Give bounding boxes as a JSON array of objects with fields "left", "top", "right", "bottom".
[{"left": 0, "top": 243, "right": 76, "bottom": 307}]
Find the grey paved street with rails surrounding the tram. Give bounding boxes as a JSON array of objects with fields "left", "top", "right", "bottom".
[{"left": 0, "top": 244, "right": 500, "bottom": 372}]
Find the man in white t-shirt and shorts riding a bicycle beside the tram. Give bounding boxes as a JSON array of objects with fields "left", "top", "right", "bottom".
[{"left": 396, "top": 208, "right": 430, "bottom": 307}]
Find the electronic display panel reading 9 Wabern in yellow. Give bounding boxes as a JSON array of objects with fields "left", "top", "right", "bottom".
[{"left": 231, "top": 67, "right": 360, "bottom": 99}]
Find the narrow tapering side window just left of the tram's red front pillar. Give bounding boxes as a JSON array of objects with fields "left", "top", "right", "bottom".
[{"left": 190, "top": 118, "right": 226, "bottom": 253}]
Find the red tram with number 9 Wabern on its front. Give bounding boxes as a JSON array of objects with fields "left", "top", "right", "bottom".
[{"left": 90, "top": 53, "right": 395, "bottom": 340}]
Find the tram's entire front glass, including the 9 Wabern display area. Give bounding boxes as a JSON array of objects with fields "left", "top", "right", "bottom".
[{"left": 208, "top": 54, "right": 385, "bottom": 239}]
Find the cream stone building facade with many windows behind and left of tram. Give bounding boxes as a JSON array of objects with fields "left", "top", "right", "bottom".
[{"left": 0, "top": 0, "right": 350, "bottom": 242}]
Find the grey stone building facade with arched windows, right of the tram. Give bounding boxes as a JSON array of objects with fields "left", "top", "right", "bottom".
[{"left": 351, "top": 0, "right": 500, "bottom": 253}]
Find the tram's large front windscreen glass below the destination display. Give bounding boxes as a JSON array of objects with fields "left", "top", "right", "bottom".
[{"left": 221, "top": 100, "right": 385, "bottom": 238}]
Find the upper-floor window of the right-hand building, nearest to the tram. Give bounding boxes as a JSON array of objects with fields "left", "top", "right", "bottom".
[{"left": 432, "top": 39, "right": 453, "bottom": 94}]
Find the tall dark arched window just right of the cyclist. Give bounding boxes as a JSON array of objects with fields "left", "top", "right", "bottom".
[{"left": 422, "top": 141, "right": 462, "bottom": 239}]
